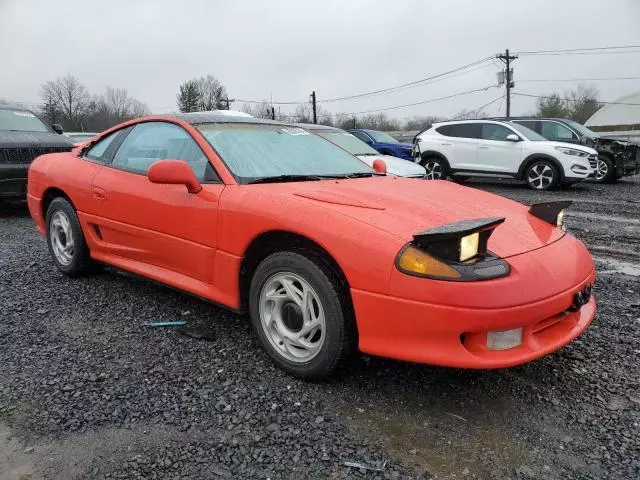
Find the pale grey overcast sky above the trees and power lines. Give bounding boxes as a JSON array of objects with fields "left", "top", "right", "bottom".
[{"left": 0, "top": 0, "right": 640, "bottom": 117}]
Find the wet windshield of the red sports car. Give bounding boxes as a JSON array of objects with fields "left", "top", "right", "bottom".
[{"left": 197, "top": 123, "right": 374, "bottom": 183}]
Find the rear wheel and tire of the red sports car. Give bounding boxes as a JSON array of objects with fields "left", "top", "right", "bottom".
[{"left": 46, "top": 197, "right": 96, "bottom": 277}]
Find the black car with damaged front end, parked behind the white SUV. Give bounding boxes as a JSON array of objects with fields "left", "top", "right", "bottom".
[{"left": 502, "top": 117, "right": 640, "bottom": 183}]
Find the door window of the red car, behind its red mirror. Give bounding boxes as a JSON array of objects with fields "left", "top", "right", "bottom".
[{"left": 112, "top": 122, "right": 217, "bottom": 181}]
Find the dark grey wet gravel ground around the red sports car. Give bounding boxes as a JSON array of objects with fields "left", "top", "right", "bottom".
[{"left": 0, "top": 177, "right": 640, "bottom": 480}]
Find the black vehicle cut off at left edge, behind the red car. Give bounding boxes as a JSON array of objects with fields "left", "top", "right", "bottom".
[{"left": 0, "top": 106, "right": 73, "bottom": 199}]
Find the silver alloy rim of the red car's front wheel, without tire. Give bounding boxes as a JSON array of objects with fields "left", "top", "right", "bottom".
[{"left": 259, "top": 272, "right": 326, "bottom": 363}]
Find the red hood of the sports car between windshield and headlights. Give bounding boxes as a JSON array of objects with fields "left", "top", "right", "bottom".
[{"left": 288, "top": 176, "right": 564, "bottom": 257}]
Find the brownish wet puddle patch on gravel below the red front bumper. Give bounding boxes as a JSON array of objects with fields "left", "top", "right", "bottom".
[{"left": 342, "top": 388, "right": 529, "bottom": 480}]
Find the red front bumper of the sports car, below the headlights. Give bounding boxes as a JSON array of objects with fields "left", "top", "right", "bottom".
[{"left": 351, "top": 272, "right": 596, "bottom": 369}]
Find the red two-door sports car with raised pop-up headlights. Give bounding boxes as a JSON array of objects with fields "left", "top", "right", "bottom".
[{"left": 28, "top": 113, "right": 596, "bottom": 378}]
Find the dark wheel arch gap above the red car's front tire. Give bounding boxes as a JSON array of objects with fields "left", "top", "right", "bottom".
[{"left": 238, "top": 230, "right": 355, "bottom": 316}]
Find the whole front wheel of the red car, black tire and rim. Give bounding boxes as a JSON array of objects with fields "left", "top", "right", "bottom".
[{"left": 249, "top": 252, "right": 355, "bottom": 379}]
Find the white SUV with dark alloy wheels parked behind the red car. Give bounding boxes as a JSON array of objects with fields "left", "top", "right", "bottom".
[{"left": 414, "top": 120, "right": 598, "bottom": 190}]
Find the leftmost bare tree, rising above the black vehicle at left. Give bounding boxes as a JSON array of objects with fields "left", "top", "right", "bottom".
[{"left": 40, "top": 75, "right": 91, "bottom": 128}]
